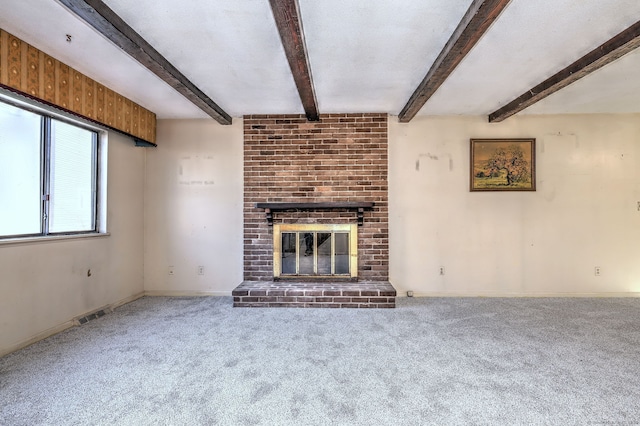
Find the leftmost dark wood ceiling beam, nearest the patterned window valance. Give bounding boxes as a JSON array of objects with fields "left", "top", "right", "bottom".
[{"left": 55, "top": 0, "right": 231, "bottom": 124}]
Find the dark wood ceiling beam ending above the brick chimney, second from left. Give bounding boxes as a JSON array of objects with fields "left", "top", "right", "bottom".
[{"left": 269, "top": 0, "right": 318, "bottom": 121}]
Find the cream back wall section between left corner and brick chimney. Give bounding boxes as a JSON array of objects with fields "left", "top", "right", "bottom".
[{"left": 145, "top": 118, "right": 243, "bottom": 295}]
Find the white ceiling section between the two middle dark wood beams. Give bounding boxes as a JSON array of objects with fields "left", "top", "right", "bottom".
[{"left": 300, "top": 0, "right": 470, "bottom": 114}]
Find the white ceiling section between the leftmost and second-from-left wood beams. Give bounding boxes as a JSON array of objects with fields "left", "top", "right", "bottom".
[{"left": 105, "top": 0, "right": 304, "bottom": 117}]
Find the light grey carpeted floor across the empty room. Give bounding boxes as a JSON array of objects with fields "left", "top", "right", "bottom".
[{"left": 0, "top": 297, "right": 640, "bottom": 425}]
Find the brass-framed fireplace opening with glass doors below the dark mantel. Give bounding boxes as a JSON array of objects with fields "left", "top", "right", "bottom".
[{"left": 273, "top": 224, "right": 358, "bottom": 278}]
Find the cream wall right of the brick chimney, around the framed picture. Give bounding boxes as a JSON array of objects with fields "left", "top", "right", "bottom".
[{"left": 389, "top": 115, "right": 640, "bottom": 296}]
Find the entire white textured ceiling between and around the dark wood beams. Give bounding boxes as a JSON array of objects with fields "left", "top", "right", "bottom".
[{"left": 0, "top": 0, "right": 640, "bottom": 118}]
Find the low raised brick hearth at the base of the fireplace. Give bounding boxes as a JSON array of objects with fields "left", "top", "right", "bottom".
[{"left": 232, "top": 281, "right": 396, "bottom": 308}]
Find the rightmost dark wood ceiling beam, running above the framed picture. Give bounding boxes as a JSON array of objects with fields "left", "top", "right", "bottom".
[{"left": 489, "top": 21, "right": 640, "bottom": 123}]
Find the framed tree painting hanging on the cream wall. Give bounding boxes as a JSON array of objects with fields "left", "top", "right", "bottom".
[{"left": 470, "top": 139, "right": 536, "bottom": 191}]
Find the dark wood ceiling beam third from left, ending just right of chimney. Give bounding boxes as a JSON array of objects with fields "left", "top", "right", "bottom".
[{"left": 398, "top": 0, "right": 510, "bottom": 123}]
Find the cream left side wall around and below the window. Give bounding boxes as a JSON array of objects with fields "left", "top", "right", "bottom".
[{"left": 0, "top": 133, "right": 145, "bottom": 355}]
